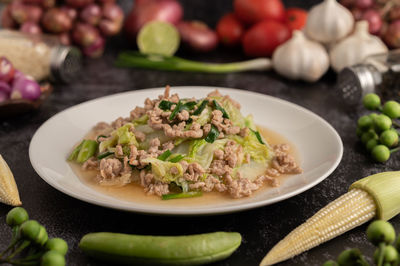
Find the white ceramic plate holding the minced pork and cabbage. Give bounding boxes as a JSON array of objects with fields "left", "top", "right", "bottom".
[{"left": 29, "top": 87, "right": 343, "bottom": 215}]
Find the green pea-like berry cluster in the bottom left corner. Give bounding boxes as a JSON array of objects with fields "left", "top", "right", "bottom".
[{"left": 0, "top": 207, "right": 68, "bottom": 266}]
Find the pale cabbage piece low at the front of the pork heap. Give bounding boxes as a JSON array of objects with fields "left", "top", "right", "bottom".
[{"left": 142, "top": 157, "right": 183, "bottom": 183}]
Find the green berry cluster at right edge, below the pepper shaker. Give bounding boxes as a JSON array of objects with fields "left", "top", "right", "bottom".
[{"left": 357, "top": 93, "right": 400, "bottom": 163}]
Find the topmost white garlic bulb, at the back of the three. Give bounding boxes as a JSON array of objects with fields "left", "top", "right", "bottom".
[{"left": 305, "top": 0, "right": 354, "bottom": 43}]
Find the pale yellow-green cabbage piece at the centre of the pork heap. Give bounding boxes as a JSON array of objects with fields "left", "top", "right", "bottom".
[{"left": 186, "top": 139, "right": 228, "bottom": 169}]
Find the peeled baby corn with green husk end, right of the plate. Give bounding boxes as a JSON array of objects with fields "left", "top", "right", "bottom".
[{"left": 260, "top": 171, "right": 400, "bottom": 266}]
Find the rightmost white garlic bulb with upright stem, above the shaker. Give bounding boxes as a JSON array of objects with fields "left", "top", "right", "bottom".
[{"left": 329, "top": 21, "right": 388, "bottom": 72}]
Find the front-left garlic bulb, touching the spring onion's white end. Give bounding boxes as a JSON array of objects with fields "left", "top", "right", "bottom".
[{"left": 272, "top": 31, "right": 329, "bottom": 82}]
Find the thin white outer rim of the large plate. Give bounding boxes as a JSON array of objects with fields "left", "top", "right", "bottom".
[{"left": 29, "top": 86, "right": 344, "bottom": 216}]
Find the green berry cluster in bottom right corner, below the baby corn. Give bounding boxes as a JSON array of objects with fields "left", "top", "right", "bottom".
[{"left": 323, "top": 220, "right": 400, "bottom": 266}]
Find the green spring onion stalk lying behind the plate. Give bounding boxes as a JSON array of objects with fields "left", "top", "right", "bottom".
[{"left": 116, "top": 51, "right": 272, "bottom": 73}]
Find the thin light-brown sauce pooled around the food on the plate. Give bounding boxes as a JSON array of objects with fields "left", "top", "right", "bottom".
[{"left": 69, "top": 126, "right": 299, "bottom": 207}]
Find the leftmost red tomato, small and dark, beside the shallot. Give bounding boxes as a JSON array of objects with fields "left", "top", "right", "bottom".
[{"left": 217, "top": 13, "right": 244, "bottom": 46}]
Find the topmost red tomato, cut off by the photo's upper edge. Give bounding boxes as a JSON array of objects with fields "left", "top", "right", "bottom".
[{"left": 233, "top": 0, "right": 285, "bottom": 24}]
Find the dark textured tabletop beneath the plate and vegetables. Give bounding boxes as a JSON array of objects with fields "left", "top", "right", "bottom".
[{"left": 0, "top": 0, "right": 400, "bottom": 265}]
